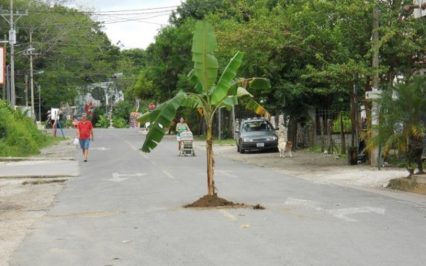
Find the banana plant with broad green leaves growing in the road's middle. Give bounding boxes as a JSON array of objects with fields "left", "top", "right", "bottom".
[{"left": 140, "top": 21, "right": 270, "bottom": 196}]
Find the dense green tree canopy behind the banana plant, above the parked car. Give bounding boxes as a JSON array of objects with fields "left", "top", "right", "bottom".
[{"left": 135, "top": 0, "right": 426, "bottom": 121}]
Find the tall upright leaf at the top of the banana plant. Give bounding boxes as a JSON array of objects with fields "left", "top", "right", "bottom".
[{"left": 192, "top": 21, "right": 219, "bottom": 92}]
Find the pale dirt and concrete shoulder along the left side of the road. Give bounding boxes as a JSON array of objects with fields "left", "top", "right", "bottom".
[{"left": 0, "top": 140, "right": 78, "bottom": 266}]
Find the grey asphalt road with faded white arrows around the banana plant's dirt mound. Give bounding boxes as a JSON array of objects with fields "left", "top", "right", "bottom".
[{"left": 11, "top": 130, "right": 426, "bottom": 266}]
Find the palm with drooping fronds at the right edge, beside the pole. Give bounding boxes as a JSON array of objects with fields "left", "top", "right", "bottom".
[{"left": 374, "top": 76, "right": 426, "bottom": 177}]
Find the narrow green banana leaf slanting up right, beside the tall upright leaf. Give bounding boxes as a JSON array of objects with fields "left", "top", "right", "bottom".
[{"left": 210, "top": 52, "right": 244, "bottom": 105}]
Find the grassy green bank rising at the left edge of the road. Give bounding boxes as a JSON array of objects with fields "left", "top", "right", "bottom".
[{"left": 0, "top": 100, "right": 49, "bottom": 156}]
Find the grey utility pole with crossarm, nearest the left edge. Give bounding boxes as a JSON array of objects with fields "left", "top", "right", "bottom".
[{"left": 0, "top": 0, "right": 28, "bottom": 107}]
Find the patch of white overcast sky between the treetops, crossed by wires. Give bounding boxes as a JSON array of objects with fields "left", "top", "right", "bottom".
[{"left": 65, "top": 0, "right": 182, "bottom": 49}]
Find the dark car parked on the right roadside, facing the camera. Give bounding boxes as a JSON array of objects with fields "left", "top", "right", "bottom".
[{"left": 235, "top": 118, "right": 278, "bottom": 153}]
